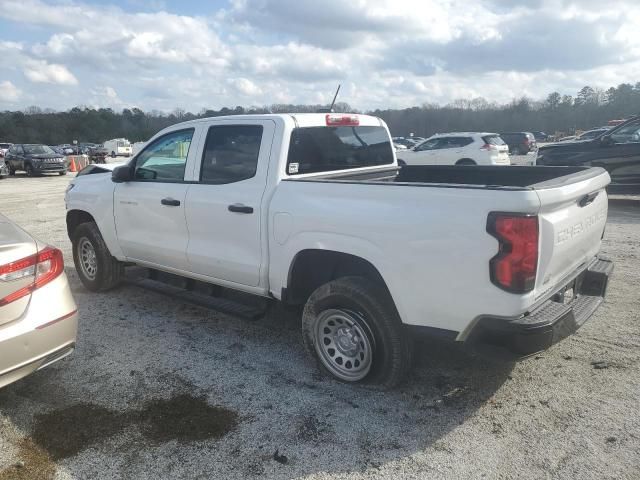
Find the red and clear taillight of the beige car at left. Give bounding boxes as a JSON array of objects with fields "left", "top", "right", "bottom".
[{"left": 0, "top": 247, "right": 64, "bottom": 307}]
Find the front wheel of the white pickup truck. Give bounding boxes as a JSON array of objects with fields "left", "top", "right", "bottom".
[{"left": 71, "top": 222, "right": 124, "bottom": 292}]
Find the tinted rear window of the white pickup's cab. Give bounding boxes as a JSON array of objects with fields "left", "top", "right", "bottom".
[{"left": 287, "top": 127, "right": 393, "bottom": 175}]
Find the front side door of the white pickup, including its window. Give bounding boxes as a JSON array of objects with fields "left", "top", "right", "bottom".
[{"left": 114, "top": 128, "right": 196, "bottom": 270}]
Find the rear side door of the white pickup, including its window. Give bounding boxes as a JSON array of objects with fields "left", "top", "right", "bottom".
[{"left": 185, "top": 120, "right": 275, "bottom": 287}]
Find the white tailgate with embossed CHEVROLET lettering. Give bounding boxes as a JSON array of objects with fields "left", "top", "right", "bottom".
[{"left": 535, "top": 169, "right": 611, "bottom": 299}]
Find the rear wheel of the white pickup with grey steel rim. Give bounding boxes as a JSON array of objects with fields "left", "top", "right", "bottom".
[{"left": 302, "top": 277, "right": 411, "bottom": 389}]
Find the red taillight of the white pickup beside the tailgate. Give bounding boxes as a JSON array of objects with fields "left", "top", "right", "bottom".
[{"left": 487, "top": 212, "right": 538, "bottom": 293}]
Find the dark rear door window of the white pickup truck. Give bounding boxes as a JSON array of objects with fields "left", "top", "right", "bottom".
[{"left": 200, "top": 125, "right": 262, "bottom": 184}]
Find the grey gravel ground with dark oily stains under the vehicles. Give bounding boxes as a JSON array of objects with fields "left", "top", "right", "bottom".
[{"left": 0, "top": 171, "right": 640, "bottom": 480}]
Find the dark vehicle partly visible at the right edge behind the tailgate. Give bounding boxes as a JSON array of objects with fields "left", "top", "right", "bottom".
[{"left": 536, "top": 115, "right": 640, "bottom": 193}]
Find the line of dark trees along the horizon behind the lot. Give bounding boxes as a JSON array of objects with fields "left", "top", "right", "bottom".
[{"left": 0, "top": 82, "right": 640, "bottom": 145}]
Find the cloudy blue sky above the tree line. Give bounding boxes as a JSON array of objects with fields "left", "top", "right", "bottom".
[{"left": 0, "top": 0, "right": 640, "bottom": 113}]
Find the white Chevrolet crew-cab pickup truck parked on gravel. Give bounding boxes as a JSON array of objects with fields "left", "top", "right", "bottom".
[{"left": 66, "top": 114, "right": 613, "bottom": 386}]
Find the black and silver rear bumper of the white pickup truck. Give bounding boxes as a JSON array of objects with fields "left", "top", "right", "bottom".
[{"left": 469, "top": 258, "right": 613, "bottom": 355}]
